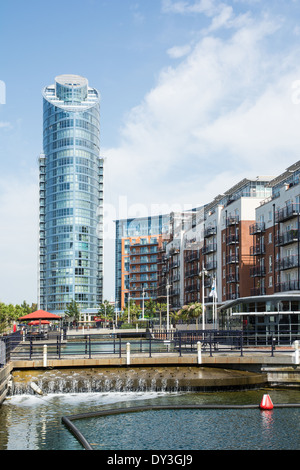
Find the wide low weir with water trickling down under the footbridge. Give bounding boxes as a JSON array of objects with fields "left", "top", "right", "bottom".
[{"left": 10, "top": 367, "right": 267, "bottom": 395}]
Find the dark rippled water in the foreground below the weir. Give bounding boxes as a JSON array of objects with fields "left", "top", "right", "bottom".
[{"left": 0, "top": 390, "right": 300, "bottom": 451}]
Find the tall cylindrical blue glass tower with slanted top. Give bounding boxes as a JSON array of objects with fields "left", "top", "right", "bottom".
[{"left": 38, "top": 75, "right": 103, "bottom": 313}]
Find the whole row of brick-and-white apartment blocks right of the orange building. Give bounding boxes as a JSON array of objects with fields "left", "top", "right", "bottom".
[{"left": 114, "top": 161, "right": 300, "bottom": 334}]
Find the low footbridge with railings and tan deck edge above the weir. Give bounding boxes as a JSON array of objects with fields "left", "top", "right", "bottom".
[{"left": 1, "top": 329, "right": 300, "bottom": 404}]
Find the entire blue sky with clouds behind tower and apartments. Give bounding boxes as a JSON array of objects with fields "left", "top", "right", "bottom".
[{"left": 0, "top": 0, "right": 300, "bottom": 303}]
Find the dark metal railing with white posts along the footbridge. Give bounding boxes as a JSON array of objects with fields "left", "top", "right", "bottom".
[{"left": 5, "top": 330, "right": 300, "bottom": 360}]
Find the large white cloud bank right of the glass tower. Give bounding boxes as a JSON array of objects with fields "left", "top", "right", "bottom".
[{"left": 104, "top": 9, "right": 300, "bottom": 218}]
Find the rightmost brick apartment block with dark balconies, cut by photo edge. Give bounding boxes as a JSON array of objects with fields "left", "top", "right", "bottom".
[{"left": 251, "top": 162, "right": 300, "bottom": 295}]
